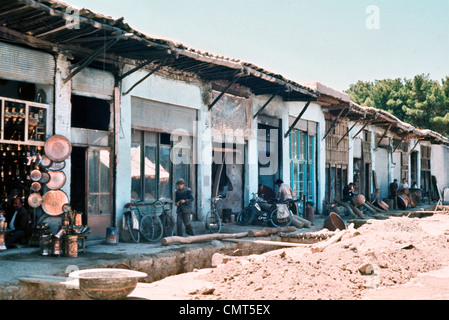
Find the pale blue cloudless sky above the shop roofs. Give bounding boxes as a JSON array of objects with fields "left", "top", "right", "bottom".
[{"left": 65, "top": 0, "right": 449, "bottom": 90}]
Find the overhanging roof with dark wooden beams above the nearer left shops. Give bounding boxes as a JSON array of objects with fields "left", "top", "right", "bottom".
[{"left": 0, "top": 0, "right": 319, "bottom": 101}]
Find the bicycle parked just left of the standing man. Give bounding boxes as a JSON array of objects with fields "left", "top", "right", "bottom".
[{"left": 123, "top": 200, "right": 164, "bottom": 243}]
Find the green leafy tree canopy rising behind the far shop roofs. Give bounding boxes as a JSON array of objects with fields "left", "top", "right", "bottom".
[{"left": 346, "top": 74, "right": 449, "bottom": 136}]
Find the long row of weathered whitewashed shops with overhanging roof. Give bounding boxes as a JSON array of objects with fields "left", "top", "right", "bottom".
[{"left": 0, "top": 0, "right": 449, "bottom": 241}]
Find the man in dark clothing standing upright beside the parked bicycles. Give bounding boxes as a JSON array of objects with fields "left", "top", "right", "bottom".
[{"left": 175, "top": 179, "right": 194, "bottom": 236}]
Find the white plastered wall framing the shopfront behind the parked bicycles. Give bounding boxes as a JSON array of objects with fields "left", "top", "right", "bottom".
[{"left": 116, "top": 67, "right": 207, "bottom": 223}]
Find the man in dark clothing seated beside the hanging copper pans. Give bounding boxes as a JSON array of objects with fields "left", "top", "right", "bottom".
[{"left": 5, "top": 197, "right": 30, "bottom": 249}]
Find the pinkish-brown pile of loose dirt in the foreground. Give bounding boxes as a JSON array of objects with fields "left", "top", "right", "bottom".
[{"left": 191, "top": 215, "right": 449, "bottom": 300}]
